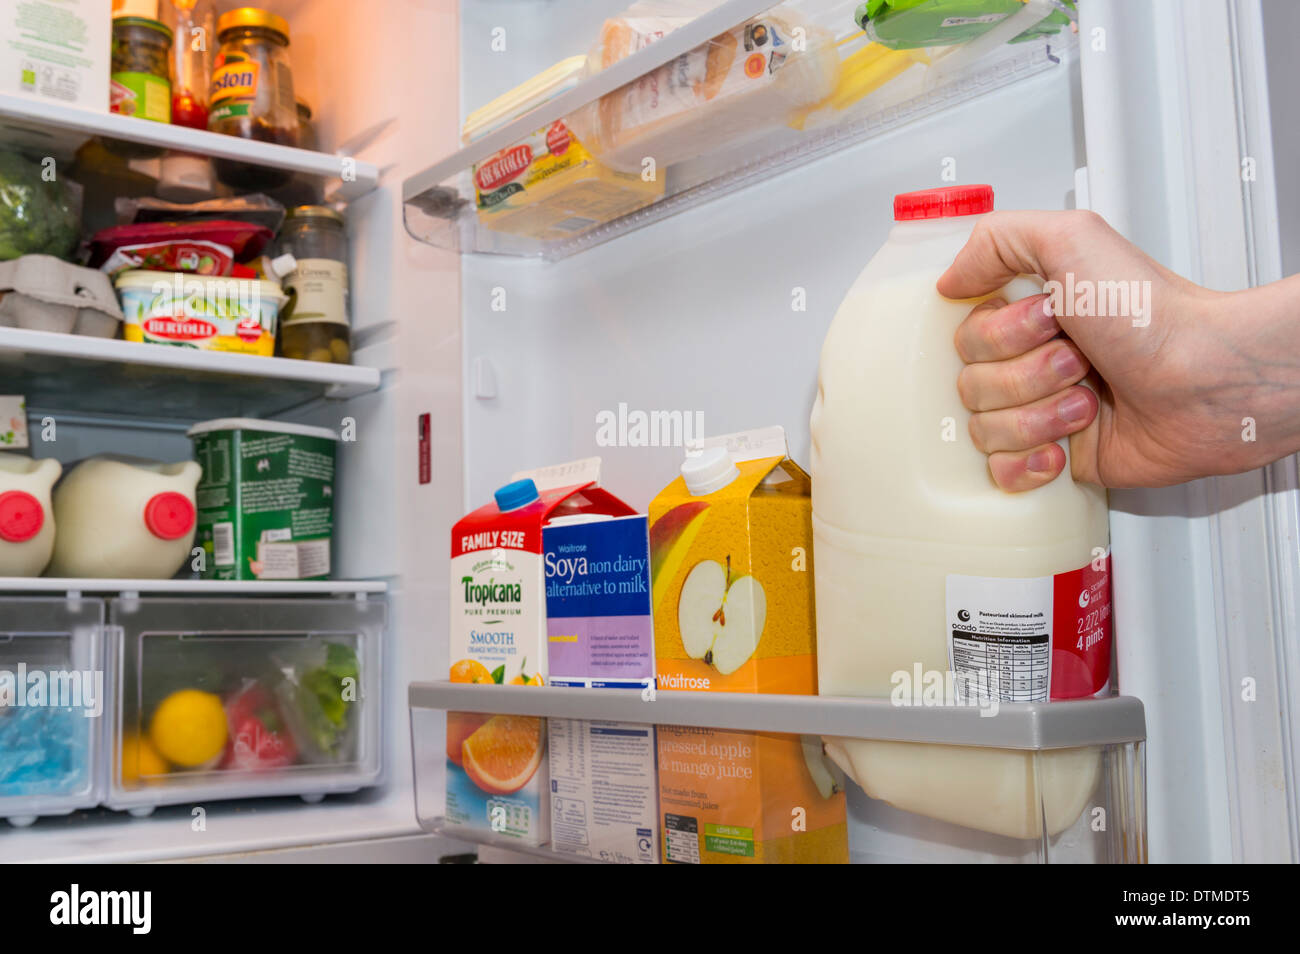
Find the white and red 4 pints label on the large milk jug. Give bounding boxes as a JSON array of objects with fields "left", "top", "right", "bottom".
[{"left": 946, "top": 554, "right": 1110, "bottom": 703}]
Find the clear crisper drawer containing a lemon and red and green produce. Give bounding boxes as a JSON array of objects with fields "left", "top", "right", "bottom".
[{"left": 105, "top": 598, "right": 386, "bottom": 815}]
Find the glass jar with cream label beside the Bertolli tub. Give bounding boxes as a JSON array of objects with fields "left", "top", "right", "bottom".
[{"left": 280, "top": 205, "right": 352, "bottom": 364}]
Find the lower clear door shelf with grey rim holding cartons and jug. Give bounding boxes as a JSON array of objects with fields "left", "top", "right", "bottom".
[{"left": 408, "top": 681, "right": 1147, "bottom": 863}]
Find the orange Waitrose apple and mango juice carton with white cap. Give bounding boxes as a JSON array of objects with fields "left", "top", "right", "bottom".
[{"left": 650, "top": 428, "right": 849, "bottom": 864}]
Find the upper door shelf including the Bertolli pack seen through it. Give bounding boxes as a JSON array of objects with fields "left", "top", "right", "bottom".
[{"left": 403, "top": 0, "right": 1076, "bottom": 260}]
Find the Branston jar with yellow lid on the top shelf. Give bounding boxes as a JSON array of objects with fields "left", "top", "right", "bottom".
[{"left": 208, "top": 6, "right": 298, "bottom": 190}]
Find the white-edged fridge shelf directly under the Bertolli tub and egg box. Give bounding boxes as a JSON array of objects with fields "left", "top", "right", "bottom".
[{"left": 0, "top": 328, "right": 380, "bottom": 421}]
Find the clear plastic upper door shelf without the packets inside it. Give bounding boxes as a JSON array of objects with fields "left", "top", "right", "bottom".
[{"left": 402, "top": 0, "right": 1078, "bottom": 260}]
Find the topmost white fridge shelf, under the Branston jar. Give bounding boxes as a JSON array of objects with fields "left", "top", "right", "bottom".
[{"left": 0, "top": 94, "right": 380, "bottom": 201}]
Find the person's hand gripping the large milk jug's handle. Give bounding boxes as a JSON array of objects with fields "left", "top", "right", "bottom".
[{"left": 937, "top": 212, "right": 1300, "bottom": 491}]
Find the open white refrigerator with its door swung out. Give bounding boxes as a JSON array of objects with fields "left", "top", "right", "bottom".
[{"left": 0, "top": 0, "right": 1300, "bottom": 863}]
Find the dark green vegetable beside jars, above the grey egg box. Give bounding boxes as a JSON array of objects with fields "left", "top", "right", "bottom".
[{"left": 0, "top": 151, "right": 81, "bottom": 261}]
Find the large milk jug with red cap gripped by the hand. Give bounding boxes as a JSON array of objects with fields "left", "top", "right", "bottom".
[{"left": 811, "top": 186, "right": 1110, "bottom": 837}]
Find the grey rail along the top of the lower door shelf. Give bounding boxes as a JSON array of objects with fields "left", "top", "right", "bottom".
[{"left": 408, "top": 680, "right": 1147, "bottom": 751}]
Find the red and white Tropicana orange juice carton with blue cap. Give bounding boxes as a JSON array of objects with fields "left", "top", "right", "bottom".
[{"left": 445, "top": 465, "right": 634, "bottom": 845}]
